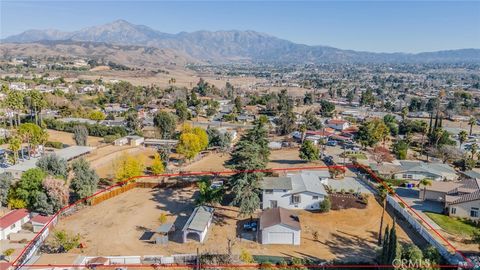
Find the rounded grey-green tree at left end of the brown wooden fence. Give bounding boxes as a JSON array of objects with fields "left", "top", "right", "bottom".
[{"left": 70, "top": 158, "right": 99, "bottom": 199}]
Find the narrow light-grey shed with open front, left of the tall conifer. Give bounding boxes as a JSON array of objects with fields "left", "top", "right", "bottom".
[{"left": 182, "top": 205, "right": 214, "bottom": 243}]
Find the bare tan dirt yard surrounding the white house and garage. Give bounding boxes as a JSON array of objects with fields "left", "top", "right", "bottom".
[{"left": 43, "top": 188, "right": 409, "bottom": 261}]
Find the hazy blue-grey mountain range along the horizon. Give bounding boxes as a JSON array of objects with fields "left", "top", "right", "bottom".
[{"left": 2, "top": 20, "right": 480, "bottom": 63}]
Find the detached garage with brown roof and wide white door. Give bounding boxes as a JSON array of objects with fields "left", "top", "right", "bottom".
[{"left": 260, "top": 207, "right": 301, "bottom": 245}]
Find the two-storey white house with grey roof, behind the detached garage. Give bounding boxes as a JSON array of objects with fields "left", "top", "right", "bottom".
[{"left": 261, "top": 171, "right": 328, "bottom": 210}]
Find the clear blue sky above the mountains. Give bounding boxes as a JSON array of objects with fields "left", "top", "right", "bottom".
[{"left": 0, "top": 0, "right": 480, "bottom": 52}]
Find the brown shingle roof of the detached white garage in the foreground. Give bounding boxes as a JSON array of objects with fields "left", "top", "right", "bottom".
[{"left": 260, "top": 207, "right": 301, "bottom": 231}]
